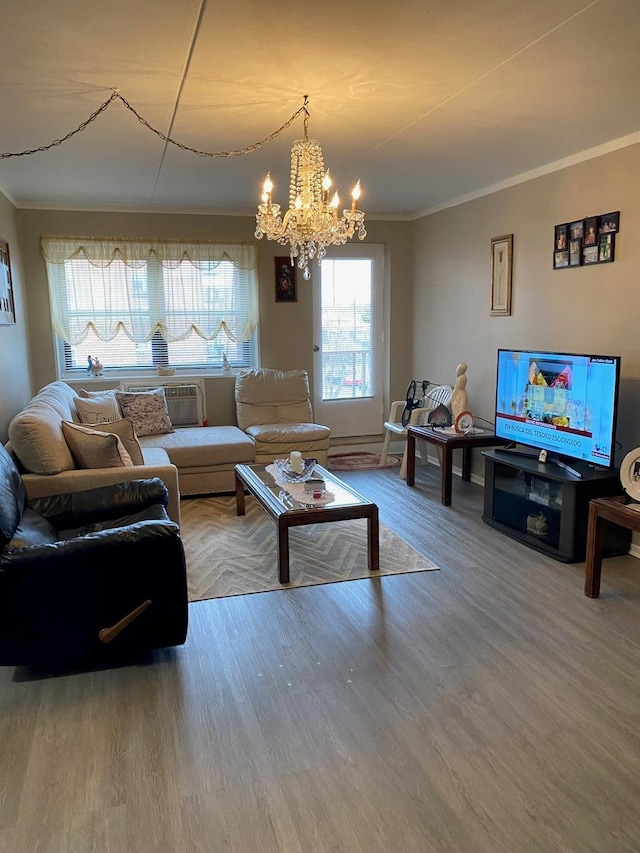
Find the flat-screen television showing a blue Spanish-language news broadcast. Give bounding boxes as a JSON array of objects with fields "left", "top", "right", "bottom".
[{"left": 496, "top": 349, "right": 620, "bottom": 467}]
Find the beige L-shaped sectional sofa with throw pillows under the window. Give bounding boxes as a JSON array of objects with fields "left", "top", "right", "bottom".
[{"left": 7, "top": 381, "right": 255, "bottom": 524}]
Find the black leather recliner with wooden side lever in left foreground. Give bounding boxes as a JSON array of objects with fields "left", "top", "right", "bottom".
[{"left": 0, "top": 445, "right": 188, "bottom": 666}]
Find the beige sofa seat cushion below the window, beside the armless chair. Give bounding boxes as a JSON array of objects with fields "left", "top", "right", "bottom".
[{"left": 140, "top": 426, "right": 254, "bottom": 469}]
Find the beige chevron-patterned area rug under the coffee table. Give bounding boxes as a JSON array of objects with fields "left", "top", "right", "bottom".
[{"left": 181, "top": 496, "right": 438, "bottom": 601}]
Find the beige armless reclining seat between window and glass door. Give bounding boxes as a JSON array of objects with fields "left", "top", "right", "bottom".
[{"left": 235, "top": 368, "right": 331, "bottom": 465}]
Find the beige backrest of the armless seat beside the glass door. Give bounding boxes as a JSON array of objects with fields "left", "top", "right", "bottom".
[{"left": 235, "top": 368, "right": 313, "bottom": 430}]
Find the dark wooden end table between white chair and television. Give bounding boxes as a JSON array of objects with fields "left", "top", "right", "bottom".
[{"left": 407, "top": 426, "right": 511, "bottom": 506}]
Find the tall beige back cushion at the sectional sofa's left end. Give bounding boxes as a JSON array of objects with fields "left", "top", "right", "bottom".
[{"left": 9, "top": 381, "right": 77, "bottom": 474}]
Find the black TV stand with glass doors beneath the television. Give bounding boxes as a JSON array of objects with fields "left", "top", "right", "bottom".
[{"left": 482, "top": 449, "right": 630, "bottom": 563}]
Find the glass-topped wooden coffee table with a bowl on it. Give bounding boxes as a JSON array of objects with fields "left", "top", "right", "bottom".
[{"left": 235, "top": 465, "right": 380, "bottom": 583}]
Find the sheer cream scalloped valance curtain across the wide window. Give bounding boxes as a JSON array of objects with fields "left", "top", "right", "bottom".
[{"left": 42, "top": 237, "right": 258, "bottom": 346}]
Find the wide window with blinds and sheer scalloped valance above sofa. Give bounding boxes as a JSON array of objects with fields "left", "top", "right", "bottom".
[{"left": 42, "top": 238, "right": 257, "bottom": 378}]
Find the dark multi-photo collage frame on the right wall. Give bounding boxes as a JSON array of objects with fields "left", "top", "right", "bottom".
[{"left": 553, "top": 210, "right": 620, "bottom": 270}]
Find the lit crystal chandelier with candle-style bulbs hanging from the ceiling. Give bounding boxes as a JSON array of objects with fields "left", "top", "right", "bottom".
[{"left": 255, "top": 95, "right": 367, "bottom": 279}]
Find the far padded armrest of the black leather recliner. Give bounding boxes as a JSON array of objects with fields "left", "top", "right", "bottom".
[{"left": 29, "top": 477, "right": 169, "bottom": 529}]
